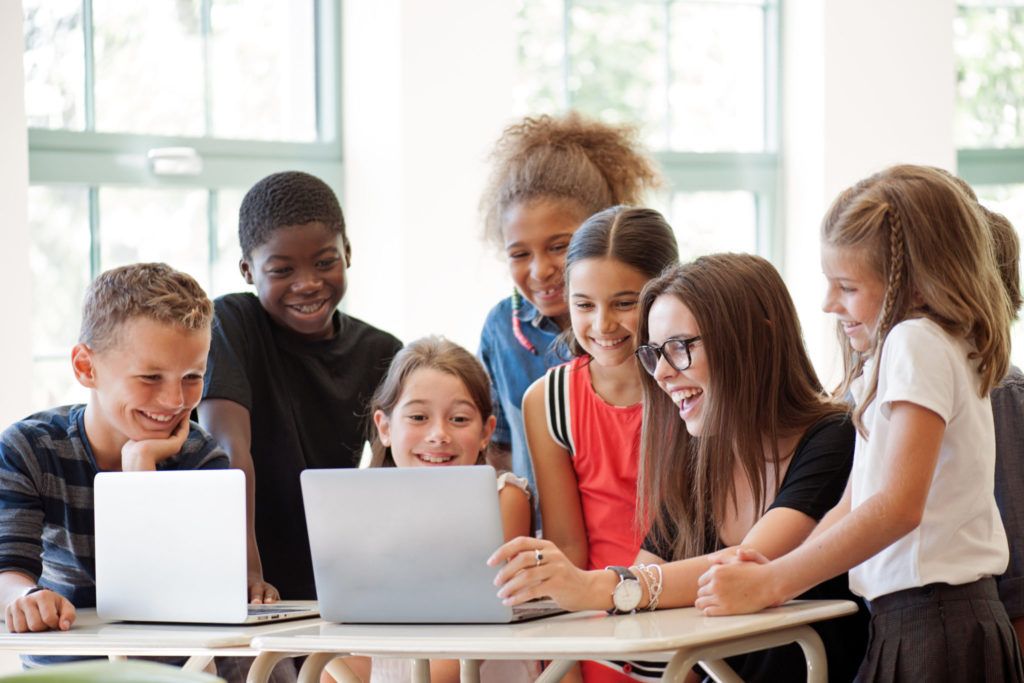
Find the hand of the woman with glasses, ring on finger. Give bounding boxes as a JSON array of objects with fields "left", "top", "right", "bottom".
[{"left": 487, "top": 536, "right": 598, "bottom": 610}]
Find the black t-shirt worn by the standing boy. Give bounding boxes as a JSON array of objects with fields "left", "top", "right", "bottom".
[{"left": 203, "top": 294, "right": 401, "bottom": 600}]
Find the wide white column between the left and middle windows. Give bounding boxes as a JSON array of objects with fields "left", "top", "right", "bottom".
[{"left": 343, "top": 0, "right": 515, "bottom": 350}]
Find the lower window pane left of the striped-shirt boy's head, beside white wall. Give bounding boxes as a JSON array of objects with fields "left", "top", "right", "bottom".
[{"left": 29, "top": 186, "right": 90, "bottom": 358}]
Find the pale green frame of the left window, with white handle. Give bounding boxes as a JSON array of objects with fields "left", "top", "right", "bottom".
[{"left": 28, "top": 0, "right": 344, "bottom": 401}]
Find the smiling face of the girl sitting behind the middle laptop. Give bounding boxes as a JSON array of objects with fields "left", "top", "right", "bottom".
[{"left": 374, "top": 368, "right": 496, "bottom": 467}]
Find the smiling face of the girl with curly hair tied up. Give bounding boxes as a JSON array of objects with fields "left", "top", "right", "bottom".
[{"left": 502, "top": 200, "right": 586, "bottom": 319}]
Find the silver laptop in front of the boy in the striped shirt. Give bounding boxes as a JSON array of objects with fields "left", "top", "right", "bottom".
[{"left": 94, "top": 470, "right": 318, "bottom": 624}]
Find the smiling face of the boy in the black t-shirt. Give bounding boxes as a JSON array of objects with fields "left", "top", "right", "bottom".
[{"left": 239, "top": 221, "right": 351, "bottom": 340}]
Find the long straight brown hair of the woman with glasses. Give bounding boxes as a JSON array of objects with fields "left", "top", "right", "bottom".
[{"left": 638, "top": 254, "right": 846, "bottom": 560}]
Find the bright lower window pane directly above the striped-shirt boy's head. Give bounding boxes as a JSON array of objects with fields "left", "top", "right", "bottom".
[{"left": 99, "top": 187, "right": 210, "bottom": 291}]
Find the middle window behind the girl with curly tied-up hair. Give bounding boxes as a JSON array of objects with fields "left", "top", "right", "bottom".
[{"left": 515, "top": 0, "right": 782, "bottom": 262}]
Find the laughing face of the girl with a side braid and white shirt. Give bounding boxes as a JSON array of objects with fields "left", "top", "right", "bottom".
[{"left": 821, "top": 245, "right": 886, "bottom": 353}]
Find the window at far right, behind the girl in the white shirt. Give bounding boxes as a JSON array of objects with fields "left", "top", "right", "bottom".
[{"left": 953, "top": 0, "right": 1024, "bottom": 366}]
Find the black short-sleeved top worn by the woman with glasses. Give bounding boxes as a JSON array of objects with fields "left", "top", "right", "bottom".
[{"left": 643, "top": 415, "right": 868, "bottom": 681}]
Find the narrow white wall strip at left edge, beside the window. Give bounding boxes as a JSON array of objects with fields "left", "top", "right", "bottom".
[{"left": 0, "top": 1, "right": 32, "bottom": 428}]
